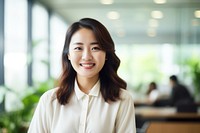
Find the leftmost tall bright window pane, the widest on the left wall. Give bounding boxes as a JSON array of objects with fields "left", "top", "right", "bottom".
[{"left": 4, "top": 0, "right": 27, "bottom": 91}]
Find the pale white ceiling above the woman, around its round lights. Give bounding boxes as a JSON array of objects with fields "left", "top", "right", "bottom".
[{"left": 36, "top": 0, "right": 200, "bottom": 44}]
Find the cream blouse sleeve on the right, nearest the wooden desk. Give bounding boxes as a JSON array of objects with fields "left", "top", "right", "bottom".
[{"left": 116, "top": 92, "right": 136, "bottom": 133}]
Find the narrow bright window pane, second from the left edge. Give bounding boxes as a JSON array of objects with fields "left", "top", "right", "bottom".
[{"left": 32, "top": 4, "right": 49, "bottom": 82}]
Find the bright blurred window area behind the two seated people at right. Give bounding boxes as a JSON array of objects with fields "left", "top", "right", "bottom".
[{"left": 116, "top": 44, "right": 200, "bottom": 99}]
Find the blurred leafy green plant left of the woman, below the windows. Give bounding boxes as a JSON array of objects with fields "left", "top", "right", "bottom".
[{"left": 0, "top": 79, "right": 55, "bottom": 133}]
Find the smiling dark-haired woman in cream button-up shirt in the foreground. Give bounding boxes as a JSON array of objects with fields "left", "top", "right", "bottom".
[{"left": 28, "top": 18, "right": 136, "bottom": 133}]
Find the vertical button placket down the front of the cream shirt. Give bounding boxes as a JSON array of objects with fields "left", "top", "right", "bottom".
[{"left": 79, "top": 95, "right": 89, "bottom": 133}]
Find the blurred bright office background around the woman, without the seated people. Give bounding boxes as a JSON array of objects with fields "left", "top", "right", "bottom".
[{"left": 0, "top": 0, "right": 200, "bottom": 133}]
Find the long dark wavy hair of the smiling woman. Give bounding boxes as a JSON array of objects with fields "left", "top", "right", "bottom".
[{"left": 57, "top": 18, "right": 127, "bottom": 105}]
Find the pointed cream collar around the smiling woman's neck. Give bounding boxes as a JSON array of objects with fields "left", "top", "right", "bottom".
[{"left": 74, "top": 79, "right": 100, "bottom": 100}]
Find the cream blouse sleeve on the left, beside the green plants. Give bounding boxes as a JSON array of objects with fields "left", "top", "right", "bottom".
[{"left": 28, "top": 93, "right": 51, "bottom": 133}]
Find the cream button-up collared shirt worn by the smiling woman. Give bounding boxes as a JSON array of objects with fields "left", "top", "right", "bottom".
[{"left": 28, "top": 81, "right": 136, "bottom": 133}]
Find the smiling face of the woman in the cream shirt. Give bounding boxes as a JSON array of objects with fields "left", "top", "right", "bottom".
[{"left": 68, "top": 28, "right": 106, "bottom": 78}]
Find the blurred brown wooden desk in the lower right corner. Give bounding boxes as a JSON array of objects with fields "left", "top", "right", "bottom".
[{"left": 135, "top": 106, "right": 200, "bottom": 133}]
